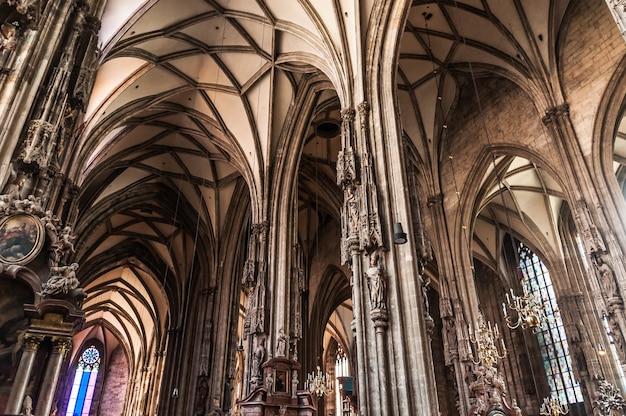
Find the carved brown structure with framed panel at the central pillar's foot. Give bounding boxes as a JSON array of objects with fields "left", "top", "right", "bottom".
[{"left": 239, "top": 357, "right": 317, "bottom": 416}]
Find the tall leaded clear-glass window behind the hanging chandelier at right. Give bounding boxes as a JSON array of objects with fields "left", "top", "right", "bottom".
[{"left": 518, "top": 243, "right": 583, "bottom": 404}]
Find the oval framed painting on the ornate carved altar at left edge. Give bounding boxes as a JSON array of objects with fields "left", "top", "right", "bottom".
[{"left": 0, "top": 214, "right": 45, "bottom": 264}]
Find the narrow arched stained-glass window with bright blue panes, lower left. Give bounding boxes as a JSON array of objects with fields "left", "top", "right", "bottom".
[{"left": 65, "top": 345, "right": 100, "bottom": 416}]
